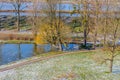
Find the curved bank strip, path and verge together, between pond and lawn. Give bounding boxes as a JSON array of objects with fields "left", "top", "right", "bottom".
[{"left": 0, "top": 50, "right": 91, "bottom": 72}]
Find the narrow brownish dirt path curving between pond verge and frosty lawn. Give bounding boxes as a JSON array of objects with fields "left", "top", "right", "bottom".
[{"left": 0, "top": 50, "right": 95, "bottom": 72}]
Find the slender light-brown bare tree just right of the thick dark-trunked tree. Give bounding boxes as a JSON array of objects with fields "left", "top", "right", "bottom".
[{"left": 88, "top": 0, "right": 102, "bottom": 49}]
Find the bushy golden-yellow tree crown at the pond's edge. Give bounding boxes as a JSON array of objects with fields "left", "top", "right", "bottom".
[{"left": 35, "top": 21, "right": 71, "bottom": 49}]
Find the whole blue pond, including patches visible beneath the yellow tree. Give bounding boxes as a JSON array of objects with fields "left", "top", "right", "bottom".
[{"left": 0, "top": 44, "right": 79, "bottom": 65}]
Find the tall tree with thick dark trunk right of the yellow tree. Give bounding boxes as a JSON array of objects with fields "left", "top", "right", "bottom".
[{"left": 73, "top": 0, "right": 91, "bottom": 47}]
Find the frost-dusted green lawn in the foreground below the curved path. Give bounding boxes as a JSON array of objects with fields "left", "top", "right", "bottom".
[{"left": 0, "top": 52, "right": 120, "bottom": 80}]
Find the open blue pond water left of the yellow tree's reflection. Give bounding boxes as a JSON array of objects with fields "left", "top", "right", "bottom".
[{"left": 0, "top": 44, "right": 34, "bottom": 65}]
